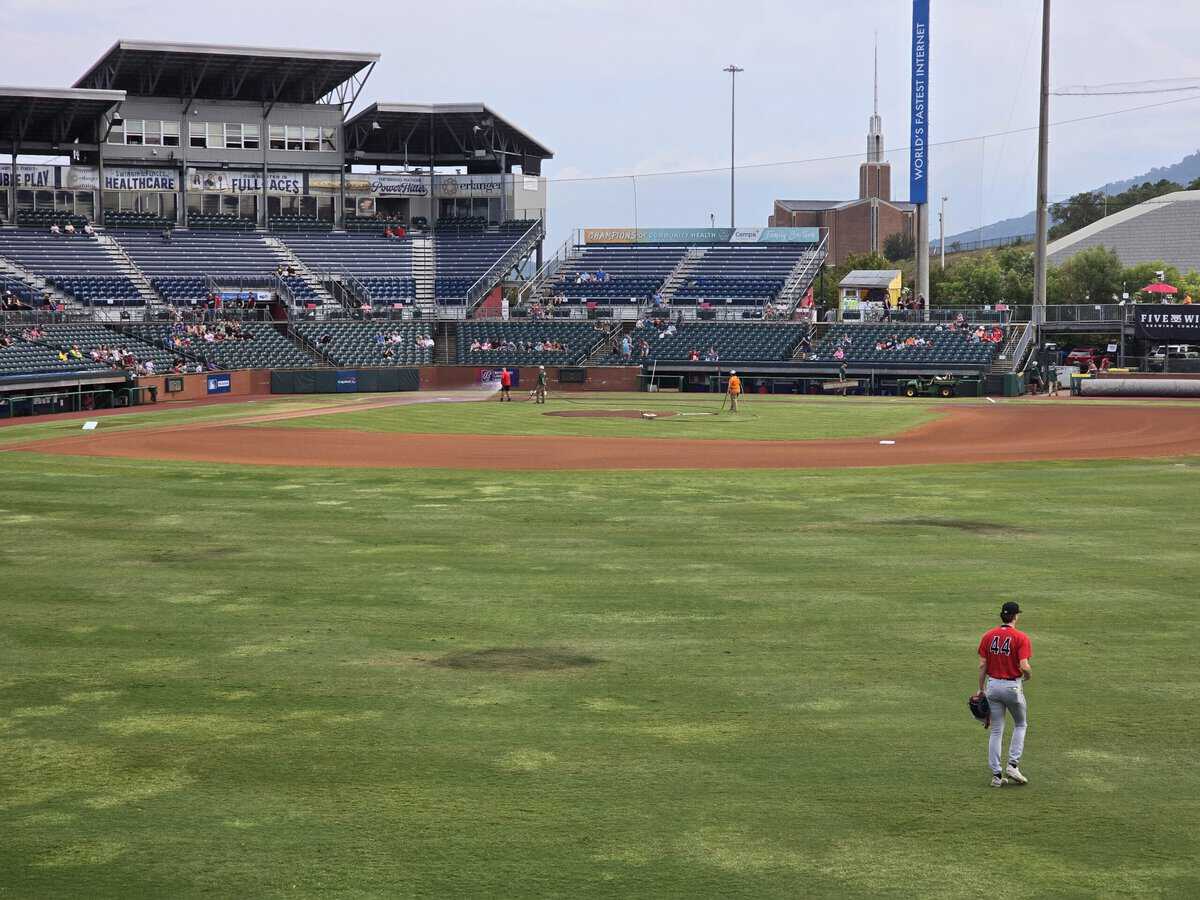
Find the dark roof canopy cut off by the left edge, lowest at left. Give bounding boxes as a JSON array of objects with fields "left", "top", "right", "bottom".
[{"left": 0, "top": 86, "right": 125, "bottom": 152}]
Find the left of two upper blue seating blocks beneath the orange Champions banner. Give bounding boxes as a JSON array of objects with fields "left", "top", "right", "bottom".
[{"left": 548, "top": 245, "right": 688, "bottom": 305}]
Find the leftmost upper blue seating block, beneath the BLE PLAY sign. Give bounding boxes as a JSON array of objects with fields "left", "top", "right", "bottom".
[{"left": 0, "top": 228, "right": 143, "bottom": 306}]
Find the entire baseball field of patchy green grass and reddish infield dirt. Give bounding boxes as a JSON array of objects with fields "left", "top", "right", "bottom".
[{"left": 0, "top": 395, "right": 1200, "bottom": 898}]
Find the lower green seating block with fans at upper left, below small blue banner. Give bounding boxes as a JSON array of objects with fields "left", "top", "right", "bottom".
[{"left": 131, "top": 323, "right": 313, "bottom": 368}]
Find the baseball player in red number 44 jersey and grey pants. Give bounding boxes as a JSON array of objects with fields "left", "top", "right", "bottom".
[{"left": 979, "top": 600, "right": 1033, "bottom": 787}]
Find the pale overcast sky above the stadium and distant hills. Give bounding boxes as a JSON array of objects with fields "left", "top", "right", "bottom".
[{"left": 9, "top": 0, "right": 1200, "bottom": 247}]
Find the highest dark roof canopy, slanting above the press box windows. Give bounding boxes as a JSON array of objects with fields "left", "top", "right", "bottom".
[{"left": 74, "top": 40, "right": 379, "bottom": 106}]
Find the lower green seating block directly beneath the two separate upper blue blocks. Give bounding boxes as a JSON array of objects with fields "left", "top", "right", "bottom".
[{"left": 607, "top": 322, "right": 808, "bottom": 364}]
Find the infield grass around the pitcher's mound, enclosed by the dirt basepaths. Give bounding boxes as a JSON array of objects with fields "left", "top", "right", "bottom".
[{"left": 263, "top": 394, "right": 944, "bottom": 440}]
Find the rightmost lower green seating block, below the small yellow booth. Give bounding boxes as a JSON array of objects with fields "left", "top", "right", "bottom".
[{"left": 809, "top": 323, "right": 998, "bottom": 367}]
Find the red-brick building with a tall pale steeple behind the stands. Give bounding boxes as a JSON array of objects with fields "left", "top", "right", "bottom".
[{"left": 767, "top": 57, "right": 916, "bottom": 265}]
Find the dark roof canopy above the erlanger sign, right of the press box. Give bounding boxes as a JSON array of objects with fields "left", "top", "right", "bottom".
[{"left": 346, "top": 103, "right": 554, "bottom": 175}]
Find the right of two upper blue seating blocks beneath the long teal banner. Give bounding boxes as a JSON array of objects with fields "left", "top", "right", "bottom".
[{"left": 674, "top": 244, "right": 814, "bottom": 306}]
